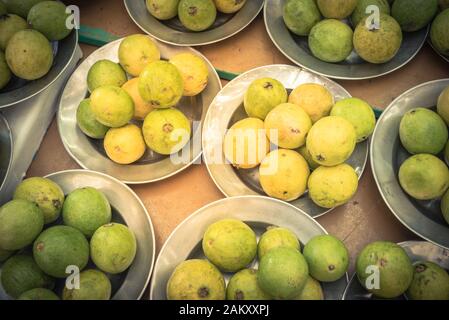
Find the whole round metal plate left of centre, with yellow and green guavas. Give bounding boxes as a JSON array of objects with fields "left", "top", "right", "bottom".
[{"left": 58, "top": 40, "right": 221, "bottom": 184}]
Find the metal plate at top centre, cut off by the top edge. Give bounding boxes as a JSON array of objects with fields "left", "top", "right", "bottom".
[{"left": 124, "top": 0, "right": 264, "bottom": 46}]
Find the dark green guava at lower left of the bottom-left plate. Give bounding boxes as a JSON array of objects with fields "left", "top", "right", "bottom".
[{"left": 1, "top": 254, "right": 55, "bottom": 298}]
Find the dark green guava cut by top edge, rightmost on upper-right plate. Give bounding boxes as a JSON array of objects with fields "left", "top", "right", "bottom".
[{"left": 391, "top": 0, "right": 438, "bottom": 32}]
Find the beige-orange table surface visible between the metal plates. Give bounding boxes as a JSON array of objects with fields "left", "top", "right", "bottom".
[{"left": 28, "top": 0, "right": 449, "bottom": 284}]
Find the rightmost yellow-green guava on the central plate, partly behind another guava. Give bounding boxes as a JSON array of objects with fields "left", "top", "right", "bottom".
[{"left": 331, "top": 98, "right": 376, "bottom": 142}]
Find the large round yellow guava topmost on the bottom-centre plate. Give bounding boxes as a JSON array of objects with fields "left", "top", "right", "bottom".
[{"left": 202, "top": 219, "right": 257, "bottom": 272}]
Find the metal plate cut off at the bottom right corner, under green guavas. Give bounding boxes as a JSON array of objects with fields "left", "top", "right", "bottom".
[{"left": 343, "top": 241, "right": 449, "bottom": 300}]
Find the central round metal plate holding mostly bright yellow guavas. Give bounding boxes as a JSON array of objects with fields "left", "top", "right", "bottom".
[{"left": 203, "top": 65, "right": 369, "bottom": 217}]
